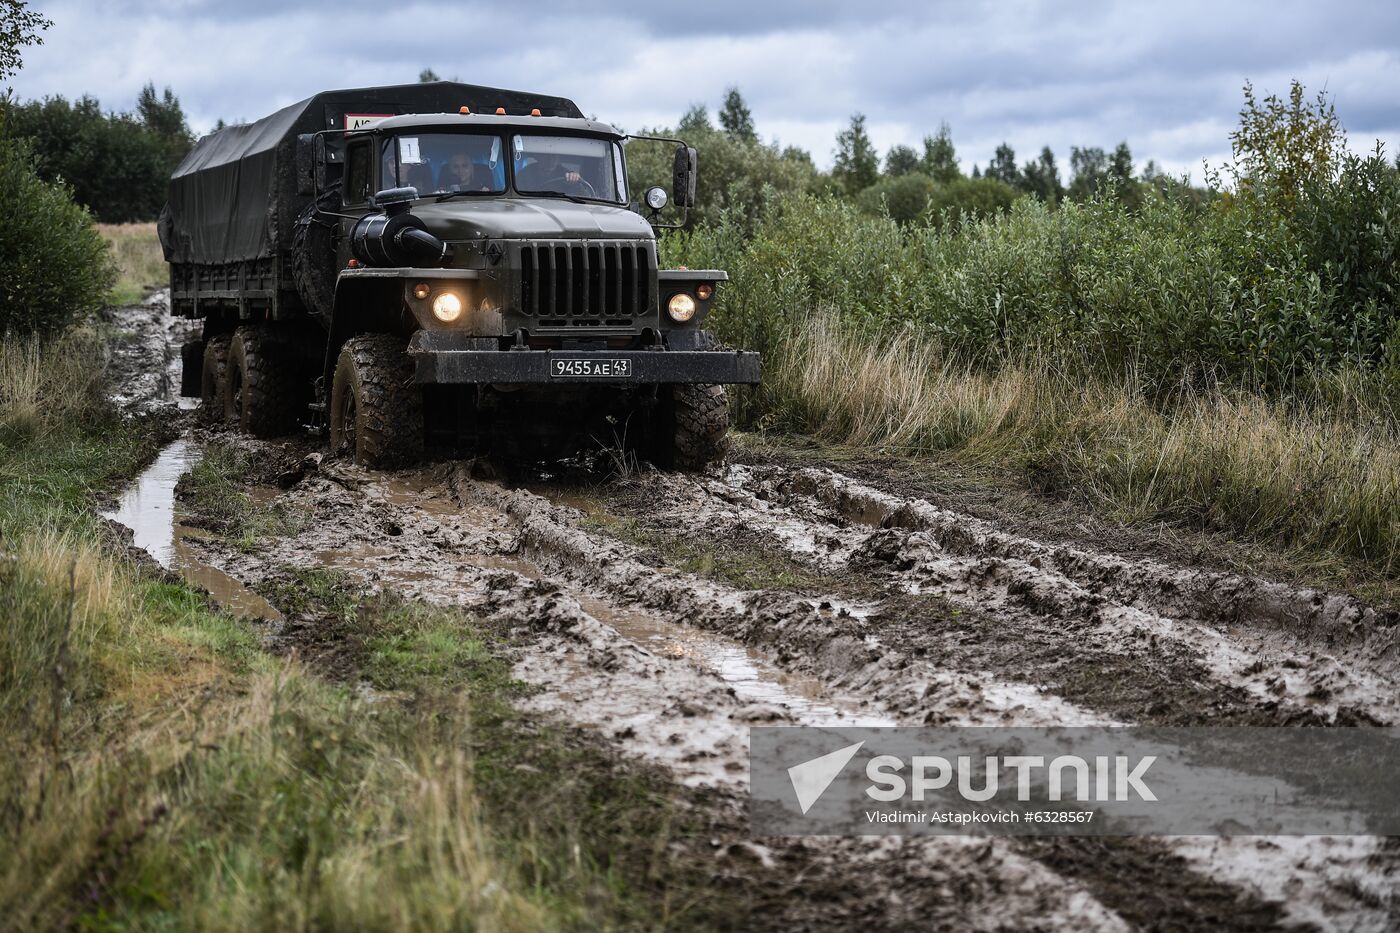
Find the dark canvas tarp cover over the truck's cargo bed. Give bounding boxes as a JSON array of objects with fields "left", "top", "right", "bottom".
[{"left": 160, "top": 81, "right": 581, "bottom": 263}]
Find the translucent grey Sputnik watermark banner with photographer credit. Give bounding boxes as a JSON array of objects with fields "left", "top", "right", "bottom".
[{"left": 750, "top": 727, "right": 1400, "bottom": 835}]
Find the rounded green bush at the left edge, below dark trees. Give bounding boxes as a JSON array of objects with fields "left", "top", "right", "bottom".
[{"left": 0, "top": 134, "right": 116, "bottom": 335}]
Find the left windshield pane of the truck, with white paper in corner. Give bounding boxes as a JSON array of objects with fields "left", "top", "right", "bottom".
[{"left": 381, "top": 133, "right": 505, "bottom": 196}]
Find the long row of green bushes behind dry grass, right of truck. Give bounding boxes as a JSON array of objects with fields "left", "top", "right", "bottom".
[{"left": 662, "top": 160, "right": 1400, "bottom": 394}]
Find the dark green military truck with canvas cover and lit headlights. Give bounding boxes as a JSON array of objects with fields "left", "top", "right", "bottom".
[{"left": 160, "top": 81, "right": 760, "bottom": 469}]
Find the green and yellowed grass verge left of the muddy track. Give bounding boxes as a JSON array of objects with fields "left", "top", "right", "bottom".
[{"left": 0, "top": 338, "right": 748, "bottom": 930}]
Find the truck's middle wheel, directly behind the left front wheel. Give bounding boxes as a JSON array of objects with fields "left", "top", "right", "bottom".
[{"left": 224, "top": 326, "right": 302, "bottom": 437}]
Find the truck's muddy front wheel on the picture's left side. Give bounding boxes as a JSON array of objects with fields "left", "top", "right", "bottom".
[{"left": 330, "top": 333, "right": 423, "bottom": 468}]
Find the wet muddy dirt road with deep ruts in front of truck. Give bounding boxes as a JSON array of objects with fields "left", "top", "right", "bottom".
[{"left": 103, "top": 294, "right": 1400, "bottom": 930}]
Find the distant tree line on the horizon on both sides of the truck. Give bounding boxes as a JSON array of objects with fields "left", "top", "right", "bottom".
[{"left": 0, "top": 69, "right": 1204, "bottom": 227}]
